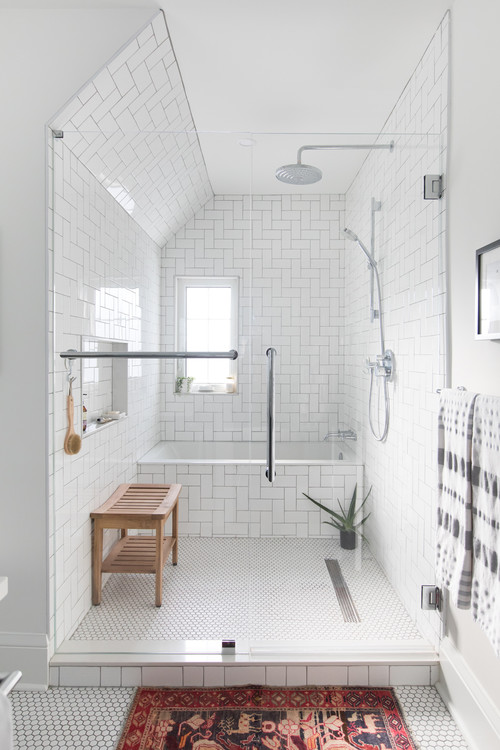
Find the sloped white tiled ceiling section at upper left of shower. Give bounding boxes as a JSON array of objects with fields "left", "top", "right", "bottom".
[{"left": 51, "top": 12, "right": 213, "bottom": 245}]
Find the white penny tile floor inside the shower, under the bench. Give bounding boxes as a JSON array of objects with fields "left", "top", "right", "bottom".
[{"left": 72, "top": 537, "right": 421, "bottom": 641}]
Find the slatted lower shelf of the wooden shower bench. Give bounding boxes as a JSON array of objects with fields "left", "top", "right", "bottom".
[{"left": 101, "top": 536, "right": 176, "bottom": 573}]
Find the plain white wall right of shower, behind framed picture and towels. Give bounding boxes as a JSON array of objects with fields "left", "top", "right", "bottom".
[{"left": 448, "top": 0, "right": 500, "bottom": 710}]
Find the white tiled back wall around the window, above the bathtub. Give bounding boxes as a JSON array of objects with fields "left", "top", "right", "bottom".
[{"left": 162, "top": 194, "right": 344, "bottom": 450}]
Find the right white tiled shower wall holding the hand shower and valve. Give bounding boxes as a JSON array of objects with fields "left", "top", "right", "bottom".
[{"left": 345, "top": 16, "right": 449, "bottom": 642}]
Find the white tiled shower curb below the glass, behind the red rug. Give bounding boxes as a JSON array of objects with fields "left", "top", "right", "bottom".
[{"left": 49, "top": 644, "right": 439, "bottom": 687}]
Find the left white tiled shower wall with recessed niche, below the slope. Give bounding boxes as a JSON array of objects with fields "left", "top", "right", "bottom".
[{"left": 49, "top": 140, "right": 160, "bottom": 646}]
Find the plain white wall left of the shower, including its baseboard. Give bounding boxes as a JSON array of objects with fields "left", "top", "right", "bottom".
[{"left": 0, "top": 10, "right": 156, "bottom": 685}]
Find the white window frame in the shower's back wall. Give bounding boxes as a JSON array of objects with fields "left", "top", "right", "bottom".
[{"left": 174, "top": 276, "right": 240, "bottom": 395}]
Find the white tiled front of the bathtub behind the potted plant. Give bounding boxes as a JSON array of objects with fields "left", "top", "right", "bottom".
[{"left": 138, "top": 462, "right": 363, "bottom": 538}]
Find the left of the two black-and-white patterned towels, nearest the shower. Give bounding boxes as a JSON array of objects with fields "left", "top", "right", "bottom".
[{"left": 436, "top": 388, "right": 476, "bottom": 609}]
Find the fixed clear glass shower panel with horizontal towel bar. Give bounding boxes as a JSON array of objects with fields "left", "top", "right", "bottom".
[{"left": 51, "top": 131, "right": 253, "bottom": 653}]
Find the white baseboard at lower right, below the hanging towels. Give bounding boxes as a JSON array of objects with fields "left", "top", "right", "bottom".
[{"left": 436, "top": 638, "right": 500, "bottom": 750}]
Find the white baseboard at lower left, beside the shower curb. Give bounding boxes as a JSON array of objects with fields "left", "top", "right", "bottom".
[{"left": 0, "top": 633, "right": 49, "bottom": 690}]
